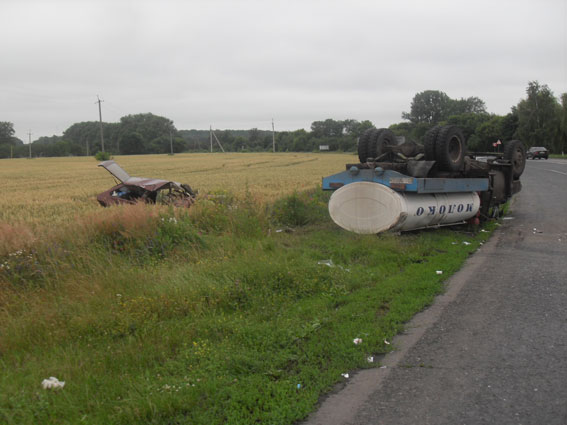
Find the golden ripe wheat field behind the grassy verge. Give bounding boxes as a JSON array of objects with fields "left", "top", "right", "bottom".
[{"left": 0, "top": 153, "right": 355, "bottom": 229}]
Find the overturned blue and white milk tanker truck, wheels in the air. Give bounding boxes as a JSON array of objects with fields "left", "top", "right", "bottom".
[{"left": 322, "top": 125, "right": 526, "bottom": 234}]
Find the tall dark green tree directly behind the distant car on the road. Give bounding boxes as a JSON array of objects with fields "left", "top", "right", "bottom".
[{"left": 517, "top": 81, "right": 561, "bottom": 150}]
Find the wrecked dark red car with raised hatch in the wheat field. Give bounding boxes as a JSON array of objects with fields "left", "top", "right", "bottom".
[{"left": 96, "top": 160, "right": 195, "bottom": 208}]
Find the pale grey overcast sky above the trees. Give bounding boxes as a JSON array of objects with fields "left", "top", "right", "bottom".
[{"left": 0, "top": 0, "right": 567, "bottom": 142}]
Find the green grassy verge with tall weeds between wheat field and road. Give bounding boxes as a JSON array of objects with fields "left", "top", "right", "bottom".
[{"left": 0, "top": 192, "right": 489, "bottom": 424}]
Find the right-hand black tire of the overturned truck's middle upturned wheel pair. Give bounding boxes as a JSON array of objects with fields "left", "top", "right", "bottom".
[{"left": 435, "top": 125, "right": 466, "bottom": 171}]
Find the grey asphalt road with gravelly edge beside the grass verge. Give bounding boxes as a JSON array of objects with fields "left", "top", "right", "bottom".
[{"left": 306, "top": 159, "right": 567, "bottom": 425}]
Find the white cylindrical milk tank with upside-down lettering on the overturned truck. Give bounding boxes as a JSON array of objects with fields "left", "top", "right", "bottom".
[{"left": 329, "top": 182, "right": 480, "bottom": 234}]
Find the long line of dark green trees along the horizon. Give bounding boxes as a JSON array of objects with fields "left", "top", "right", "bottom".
[{"left": 0, "top": 81, "right": 567, "bottom": 158}]
